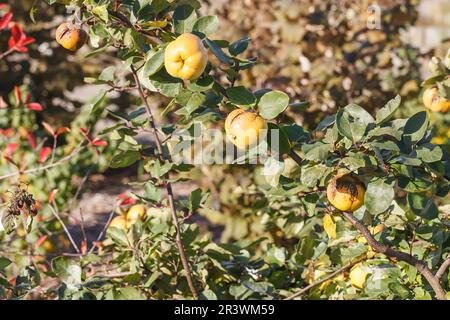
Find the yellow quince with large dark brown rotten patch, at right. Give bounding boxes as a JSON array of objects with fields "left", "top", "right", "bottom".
[{"left": 327, "top": 174, "right": 366, "bottom": 212}]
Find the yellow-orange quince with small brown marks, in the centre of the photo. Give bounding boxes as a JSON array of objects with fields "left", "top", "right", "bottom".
[{"left": 225, "top": 109, "right": 267, "bottom": 149}]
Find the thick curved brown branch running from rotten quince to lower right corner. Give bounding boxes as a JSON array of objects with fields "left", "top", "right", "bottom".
[{"left": 342, "top": 212, "right": 446, "bottom": 300}]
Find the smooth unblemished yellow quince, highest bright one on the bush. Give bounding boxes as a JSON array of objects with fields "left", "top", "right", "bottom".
[{"left": 164, "top": 33, "right": 208, "bottom": 80}]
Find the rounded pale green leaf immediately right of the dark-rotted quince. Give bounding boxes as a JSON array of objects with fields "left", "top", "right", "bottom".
[{"left": 364, "top": 178, "right": 395, "bottom": 215}]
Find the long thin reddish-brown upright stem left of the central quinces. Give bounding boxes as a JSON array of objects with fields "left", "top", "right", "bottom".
[{"left": 131, "top": 65, "right": 198, "bottom": 299}]
